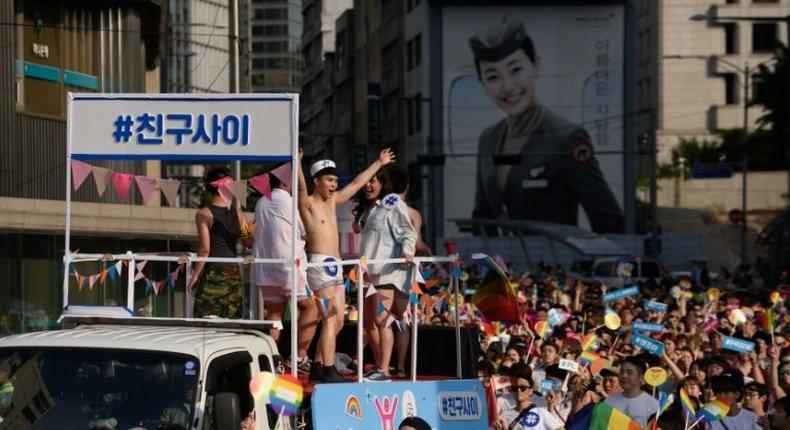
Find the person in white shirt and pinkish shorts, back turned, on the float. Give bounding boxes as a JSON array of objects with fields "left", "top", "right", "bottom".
[{"left": 251, "top": 168, "right": 318, "bottom": 373}]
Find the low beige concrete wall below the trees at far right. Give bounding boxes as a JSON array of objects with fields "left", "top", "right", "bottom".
[{"left": 658, "top": 172, "right": 788, "bottom": 211}]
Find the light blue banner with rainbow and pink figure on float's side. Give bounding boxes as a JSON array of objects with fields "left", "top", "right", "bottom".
[{"left": 312, "top": 380, "right": 488, "bottom": 430}]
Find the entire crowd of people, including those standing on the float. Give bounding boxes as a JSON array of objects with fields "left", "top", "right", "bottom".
[{"left": 190, "top": 150, "right": 790, "bottom": 430}]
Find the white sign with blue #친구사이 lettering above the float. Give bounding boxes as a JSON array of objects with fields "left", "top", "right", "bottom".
[{"left": 68, "top": 93, "right": 298, "bottom": 161}]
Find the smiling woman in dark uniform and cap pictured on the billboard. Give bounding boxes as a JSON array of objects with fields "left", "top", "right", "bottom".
[{"left": 469, "top": 20, "right": 623, "bottom": 233}]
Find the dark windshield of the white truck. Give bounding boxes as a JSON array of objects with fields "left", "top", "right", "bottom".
[{"left": 0, "top": 348, "right": 200, "bottom": 430}]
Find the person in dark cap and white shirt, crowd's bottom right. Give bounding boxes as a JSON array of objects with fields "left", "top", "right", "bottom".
[{"left": 710, "top": 369, "right": 762, "bottom": 430}]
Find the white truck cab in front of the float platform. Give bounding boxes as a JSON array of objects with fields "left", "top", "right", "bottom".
[{"left": 0, "top": 308, "right": 287, "bottom": 430}]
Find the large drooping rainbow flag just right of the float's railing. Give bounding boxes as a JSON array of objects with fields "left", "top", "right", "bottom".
[{"left": 472, "top": 254, "right": 519, "bottom": 321}]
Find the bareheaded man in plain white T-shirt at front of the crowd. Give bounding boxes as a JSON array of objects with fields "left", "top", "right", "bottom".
[{"left": 604, "top": 356, "right": 658, "bottom": 428}]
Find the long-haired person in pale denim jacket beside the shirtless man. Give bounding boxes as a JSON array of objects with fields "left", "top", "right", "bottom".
[{"left": 354, "top": 169, "right": 417, "bottom": 381}]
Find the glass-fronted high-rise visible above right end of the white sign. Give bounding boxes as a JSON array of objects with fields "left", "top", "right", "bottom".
[{"left": 250, "top": 0, "right": 304, "bottom": 92}]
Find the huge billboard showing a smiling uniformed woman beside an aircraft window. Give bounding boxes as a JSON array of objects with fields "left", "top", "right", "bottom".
[{"left": 441, "top": 4, "right": 627, "bottom": 237}]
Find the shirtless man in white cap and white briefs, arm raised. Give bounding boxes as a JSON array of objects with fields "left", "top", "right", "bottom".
[{"left": 299, "top": 149, "right": 395, "bottom": 382}]
